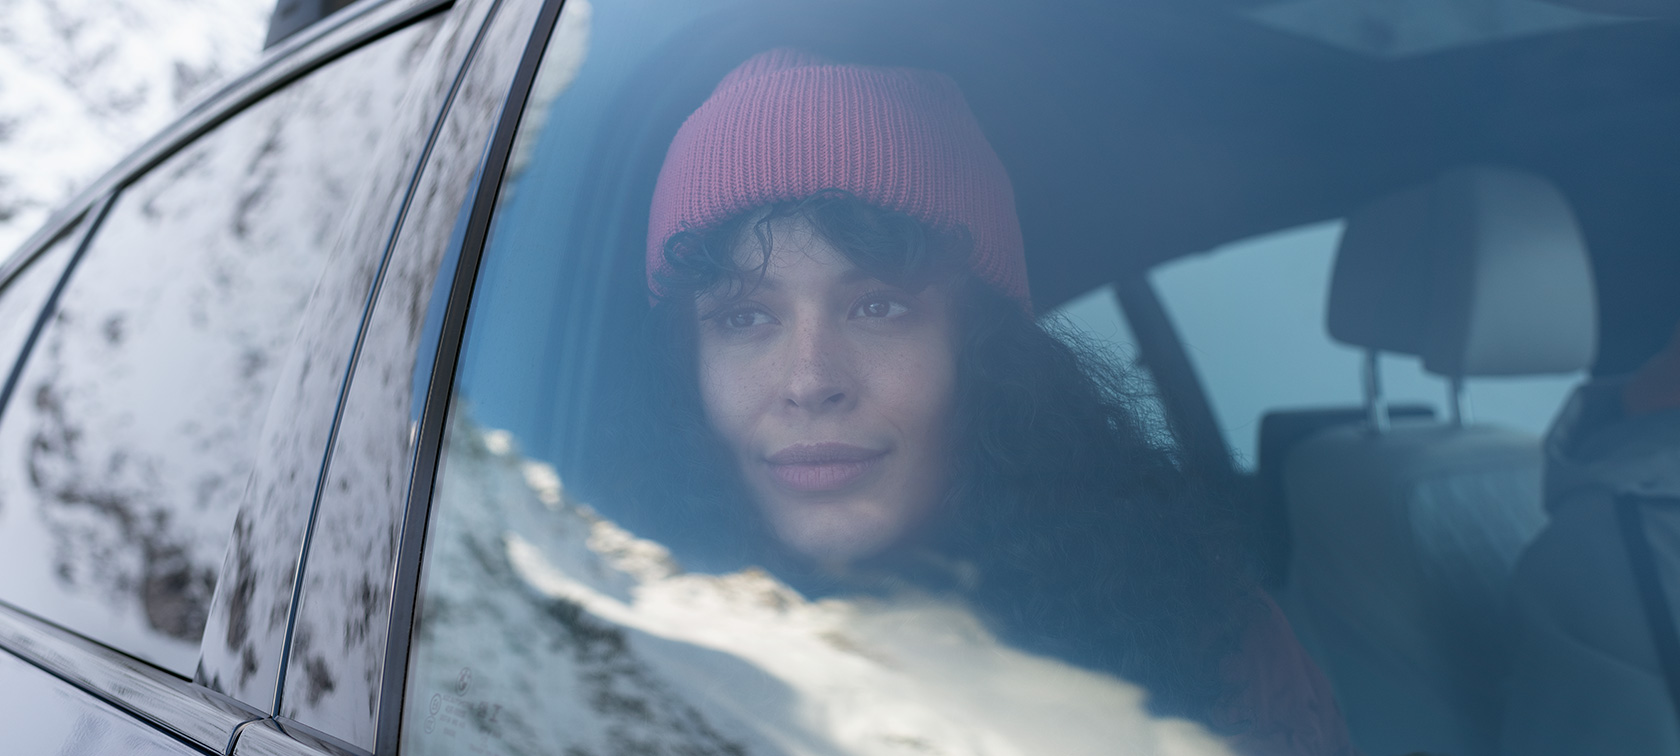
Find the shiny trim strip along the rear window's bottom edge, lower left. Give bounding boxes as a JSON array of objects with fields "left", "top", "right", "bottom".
[{"left": 0, "top": 603, "right": 262, "bottom": 753}]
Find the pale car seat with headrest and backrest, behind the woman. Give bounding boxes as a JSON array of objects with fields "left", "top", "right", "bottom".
[{"left": 1284, "top": 166, "right": 1596, "bottom": 754}]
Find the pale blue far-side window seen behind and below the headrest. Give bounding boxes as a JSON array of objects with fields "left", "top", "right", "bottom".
[{"left": 1151, "top": 222, "right": 1583, "bottom": 469}]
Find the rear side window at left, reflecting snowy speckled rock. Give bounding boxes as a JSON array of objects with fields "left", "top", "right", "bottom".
[{"left": 0, "top": 16, "right": 432, "bottom": 675}]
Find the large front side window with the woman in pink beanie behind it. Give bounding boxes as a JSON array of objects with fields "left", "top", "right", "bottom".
[{"left": 386, "top": 0, "right": 1680, "bottom": 756}]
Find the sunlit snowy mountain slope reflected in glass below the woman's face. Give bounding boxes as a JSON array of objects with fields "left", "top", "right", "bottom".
[{"left": 405, "top": 407, "right": 1226, "bottom": 754}]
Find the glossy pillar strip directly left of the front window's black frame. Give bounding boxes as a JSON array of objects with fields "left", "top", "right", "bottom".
[{"left": 279, "top": 2, "right": 541, "bottom": 751}]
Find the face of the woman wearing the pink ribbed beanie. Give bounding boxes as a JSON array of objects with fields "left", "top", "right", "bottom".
[{"left": 699, "top": 218, "right": 956, "bottom": 564}]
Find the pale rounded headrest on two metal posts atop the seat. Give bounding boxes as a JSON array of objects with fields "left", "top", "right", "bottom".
[{"left": 1329, "top": 166, "right": 1598, "bottom": 378}]
